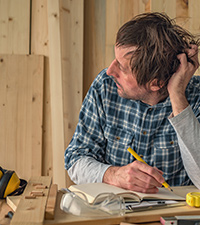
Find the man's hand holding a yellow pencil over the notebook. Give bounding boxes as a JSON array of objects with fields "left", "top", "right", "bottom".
[{"left": 103, "top": 149, "right": 170, "bottom": 193}]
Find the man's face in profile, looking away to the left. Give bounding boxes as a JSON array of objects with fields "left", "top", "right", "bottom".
[{"left": 107, "top": 47, "right": 150, "bottom": 103}]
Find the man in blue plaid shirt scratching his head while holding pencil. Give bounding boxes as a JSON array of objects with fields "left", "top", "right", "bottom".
[{"left": 65, "top": 13, "right": 200, "bottom": 193}]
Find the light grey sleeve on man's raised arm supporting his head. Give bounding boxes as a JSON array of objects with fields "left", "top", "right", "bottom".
[{"left": 169, "top": 105, "right": 200, "bottom": 189}]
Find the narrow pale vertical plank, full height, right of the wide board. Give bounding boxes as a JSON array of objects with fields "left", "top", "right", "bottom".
[{"left": 47, "top": 0, "right": 66, "bottom": 188}]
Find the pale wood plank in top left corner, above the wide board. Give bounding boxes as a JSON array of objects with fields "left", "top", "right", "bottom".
[{"left": 0, "top": 0, "right": 30, "bottom": 54}]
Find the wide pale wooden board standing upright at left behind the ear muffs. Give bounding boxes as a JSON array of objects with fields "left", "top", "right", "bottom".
[{"left": 0, "top": 55, "right": 43, "bottom": 179}]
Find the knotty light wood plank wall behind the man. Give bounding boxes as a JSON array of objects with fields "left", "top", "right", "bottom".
[{"left": 0, "top": 0, "right": 200, "bottom": 187}]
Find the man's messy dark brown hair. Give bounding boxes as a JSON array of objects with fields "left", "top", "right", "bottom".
[{"left": 116, "top": 12, "right": 199, "bottom": 93}]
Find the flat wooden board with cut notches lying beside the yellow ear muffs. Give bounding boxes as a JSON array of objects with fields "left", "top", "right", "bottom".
[{"left": 10, "top": 176, "right": 51, "bottom": 225}]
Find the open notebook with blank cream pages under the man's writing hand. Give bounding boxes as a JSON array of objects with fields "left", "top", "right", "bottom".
[{"left": 68, "top": 183, "right": 185, "bottom": 203}]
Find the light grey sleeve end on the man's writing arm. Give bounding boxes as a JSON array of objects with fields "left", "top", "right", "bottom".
[{"left": 68, "top": 156, "right": 111, "bottom": 184}]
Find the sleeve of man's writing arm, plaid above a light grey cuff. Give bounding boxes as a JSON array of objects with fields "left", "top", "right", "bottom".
[{"left": 65, "top": 72, "right": 109, "bottom": 184}]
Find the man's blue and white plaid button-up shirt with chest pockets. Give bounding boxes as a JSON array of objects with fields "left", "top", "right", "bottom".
[{"left": 65, "top": 69, "right": 200, "bottom": 186}]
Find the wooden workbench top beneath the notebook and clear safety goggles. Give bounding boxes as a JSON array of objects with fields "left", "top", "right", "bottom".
[{"left": 0, "top": 186, "right": 200, "bottom": 225}]
